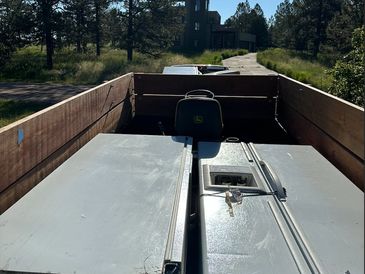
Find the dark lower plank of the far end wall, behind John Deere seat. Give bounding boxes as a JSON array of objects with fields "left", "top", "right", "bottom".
[{"left": 135, "top": 95, "right": 275, "bottom": 120}]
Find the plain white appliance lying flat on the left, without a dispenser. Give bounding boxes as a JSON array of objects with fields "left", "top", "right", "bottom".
[{"left": 0, "top": 134, "right": 191, "bottom": 273}]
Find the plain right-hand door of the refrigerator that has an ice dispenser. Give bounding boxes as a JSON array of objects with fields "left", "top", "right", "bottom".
[{"left": 253, "top": 144, "right": 364, "bottom": 273}]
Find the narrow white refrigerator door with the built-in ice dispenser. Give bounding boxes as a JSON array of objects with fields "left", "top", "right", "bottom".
[{"left": 198, "top": 142, "right": 309, "bottom": 273}]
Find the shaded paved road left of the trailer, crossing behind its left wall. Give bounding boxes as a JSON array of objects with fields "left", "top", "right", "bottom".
[{"left": 0, "top": 83, "right": 91, "bottom": 104}]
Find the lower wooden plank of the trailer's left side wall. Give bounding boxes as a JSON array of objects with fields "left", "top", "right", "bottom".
[{"left": 0, "top": 103, "right": 126, "bottom": 214}]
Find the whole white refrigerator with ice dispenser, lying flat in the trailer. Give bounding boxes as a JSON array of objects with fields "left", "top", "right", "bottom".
[{"left": 198, "top": 142, "right": 364, "bottom": 274}]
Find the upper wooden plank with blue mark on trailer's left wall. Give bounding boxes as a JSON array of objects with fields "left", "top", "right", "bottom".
[{"left": 0, "top": 74, "right": 133, "bottom": 192}]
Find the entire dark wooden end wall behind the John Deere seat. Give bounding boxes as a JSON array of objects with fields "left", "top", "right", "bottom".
[{"left": 134, "top": 73, "right": 278, "bottom": 119}]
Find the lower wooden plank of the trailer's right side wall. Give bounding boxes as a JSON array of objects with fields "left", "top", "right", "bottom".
[{"left": 279, "top": 103, "right": 364, "bottom": 190}]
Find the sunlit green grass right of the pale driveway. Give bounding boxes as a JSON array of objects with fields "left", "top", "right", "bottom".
[{"left": 257, "top": 48, "right": 333, "bottom": 91}]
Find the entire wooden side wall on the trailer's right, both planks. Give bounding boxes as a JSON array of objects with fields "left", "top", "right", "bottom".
[{"left": 278, "top": 75, "right": 364, "bottom": 190}]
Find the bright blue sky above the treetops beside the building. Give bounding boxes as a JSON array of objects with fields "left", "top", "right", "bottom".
[{"left": 209, "top": 0, "right": 284, "bottom": 24}]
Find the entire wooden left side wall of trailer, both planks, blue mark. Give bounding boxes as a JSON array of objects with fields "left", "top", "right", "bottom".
[{"left": 0, "top": 73, "right": 133, "bottom": 214}]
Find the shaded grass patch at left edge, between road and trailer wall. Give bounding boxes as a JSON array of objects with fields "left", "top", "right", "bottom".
[{"left": 0, "top": 99, "right": 48, "bottom": 128}]
